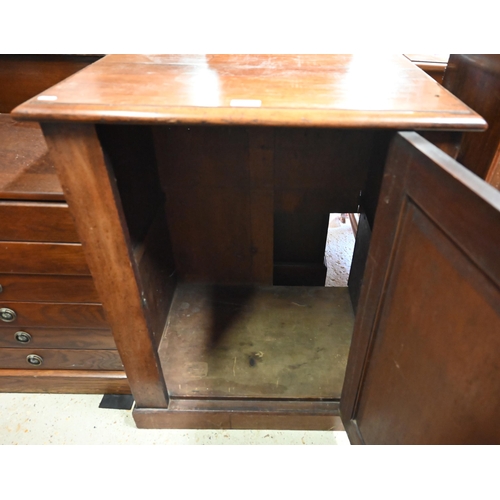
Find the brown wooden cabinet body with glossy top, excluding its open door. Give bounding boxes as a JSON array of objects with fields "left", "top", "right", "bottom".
[{"left": 13, "top": 55, "right": 486, "bottom": 429}]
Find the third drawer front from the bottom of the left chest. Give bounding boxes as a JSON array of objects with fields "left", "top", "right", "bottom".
[{"left": 0, "top": 302, "right": 109, "bottom": 329}]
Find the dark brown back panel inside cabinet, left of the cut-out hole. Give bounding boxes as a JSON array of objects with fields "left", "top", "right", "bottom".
[{"left": 154, "top": 127, "right": 274, "bottom": 283}]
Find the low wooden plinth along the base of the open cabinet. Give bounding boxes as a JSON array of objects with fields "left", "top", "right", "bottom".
[{"left": 133, "top": 399, "right": 344, "bottom": 431}]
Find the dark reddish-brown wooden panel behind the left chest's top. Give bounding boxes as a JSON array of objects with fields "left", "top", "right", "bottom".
[{"left": 0, "top": 54, "right": 101, "bottom": 113}]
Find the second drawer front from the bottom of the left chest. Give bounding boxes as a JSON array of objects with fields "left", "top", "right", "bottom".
[{"left": 0, "top": 326, "right": 116, "bottom": 349}]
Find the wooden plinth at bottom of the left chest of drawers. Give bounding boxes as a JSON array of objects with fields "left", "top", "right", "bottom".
[{"left": 0, "top": 369, "right": 130, "bottom": 394}]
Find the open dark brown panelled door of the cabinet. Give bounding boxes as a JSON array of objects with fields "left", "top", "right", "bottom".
[{"left": 340, "top": 132, "right": 500, "bottom": 444}]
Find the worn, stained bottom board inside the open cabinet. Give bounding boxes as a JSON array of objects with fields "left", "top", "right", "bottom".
[{"left": 159, "top": 284, "right": 354, "bottom": 399}]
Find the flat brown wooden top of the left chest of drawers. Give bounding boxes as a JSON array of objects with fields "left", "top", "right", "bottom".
[{"left": 0, "top": 114, "right": 64, "bottom": 201}]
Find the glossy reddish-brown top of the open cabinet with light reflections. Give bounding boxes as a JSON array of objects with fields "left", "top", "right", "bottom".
[{"left": 12, "top": 55, "right": 486, "bottom": 130}]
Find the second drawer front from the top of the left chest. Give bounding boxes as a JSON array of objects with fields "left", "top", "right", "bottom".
[{"left": 0, "top": 241, "right": 90, "bottom": 275}]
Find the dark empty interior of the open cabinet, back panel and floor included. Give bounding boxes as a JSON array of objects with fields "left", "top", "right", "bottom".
[{"left": 97, "top": 125, "right": 388, "bottom": 401}]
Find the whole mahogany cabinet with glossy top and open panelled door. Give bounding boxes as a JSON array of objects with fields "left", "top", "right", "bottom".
[{"left": 13, "top": 55, "right": 500, "bottom": 443}]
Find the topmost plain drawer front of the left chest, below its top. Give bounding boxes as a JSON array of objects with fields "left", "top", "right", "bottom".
[{"left": 0, "top": 201, "right": 80, "bottom": 243}]
